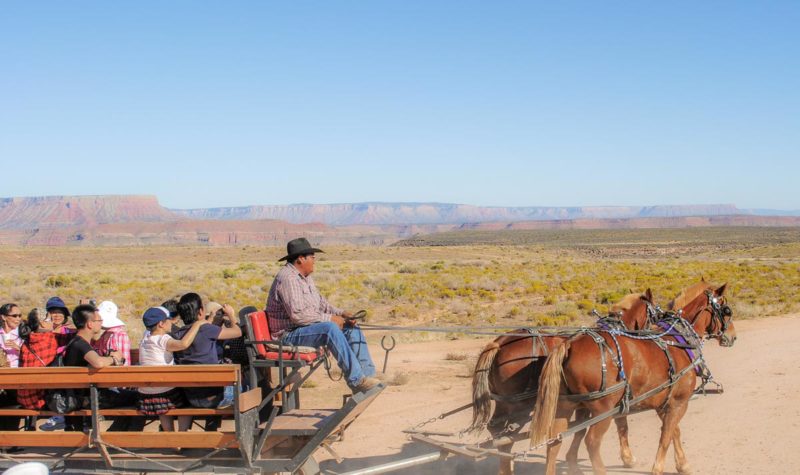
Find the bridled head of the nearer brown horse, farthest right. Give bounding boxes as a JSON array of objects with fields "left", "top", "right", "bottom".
[{"left": 670, "top": 281, "right": 736, "bottom": 346}]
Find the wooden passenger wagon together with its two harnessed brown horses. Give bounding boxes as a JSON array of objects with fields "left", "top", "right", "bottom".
[{"left": 0, "top": 284, "right": 735, "bottom": 475}]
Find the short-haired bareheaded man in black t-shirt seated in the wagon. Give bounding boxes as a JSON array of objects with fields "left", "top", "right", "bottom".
[{"left": 62, "top": 305, "right": 126, "bottom": 431}]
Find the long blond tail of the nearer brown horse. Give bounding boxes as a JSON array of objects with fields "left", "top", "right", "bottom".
[{"left": 531, "top": 341, "right": 570, "bottom": 445}]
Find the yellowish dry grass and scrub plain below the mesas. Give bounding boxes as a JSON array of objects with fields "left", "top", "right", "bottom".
[{"left": 0, "top": 229, "right": 800, "bottom": 344}]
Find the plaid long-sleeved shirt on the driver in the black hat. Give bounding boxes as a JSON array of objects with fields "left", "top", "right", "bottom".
[{"left": 267, "top": 262, "right": 343, "bottom": 340}]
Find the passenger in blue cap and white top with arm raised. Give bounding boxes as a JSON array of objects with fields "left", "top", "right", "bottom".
[{"left": 139, "top": 307, "right": 209, "bottom": 432}]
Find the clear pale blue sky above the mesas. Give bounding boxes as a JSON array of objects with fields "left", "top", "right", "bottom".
[{"left": 0, "top": 0, "right": 800, "bottom": 209}]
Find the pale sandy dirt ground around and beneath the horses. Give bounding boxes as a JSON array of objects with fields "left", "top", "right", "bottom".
[{"left": 303, "top": 315, "right": 800, "bottom": 474}]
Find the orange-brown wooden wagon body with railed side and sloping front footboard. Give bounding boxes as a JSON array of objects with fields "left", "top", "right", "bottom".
[{"left": 0, "top": 365, "right": 382, "bottom": 473}]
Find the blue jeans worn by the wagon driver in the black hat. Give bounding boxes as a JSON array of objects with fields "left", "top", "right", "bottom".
[{"left": 283, "top": 322, "right": 375, "bottom": 386}]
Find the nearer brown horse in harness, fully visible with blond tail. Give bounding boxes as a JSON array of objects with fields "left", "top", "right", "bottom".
[{"left": 531, "top": 282, "right": 736, "bottom": 475}]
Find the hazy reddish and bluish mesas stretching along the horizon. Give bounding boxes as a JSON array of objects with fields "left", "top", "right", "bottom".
[{"left": 0, "top": 195, "right": 800, "bottom": 246}]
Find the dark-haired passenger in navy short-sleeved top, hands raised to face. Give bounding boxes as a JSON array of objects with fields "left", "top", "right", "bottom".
[{"left": 173, "top": 292, "right": 242, "bottom": 430}]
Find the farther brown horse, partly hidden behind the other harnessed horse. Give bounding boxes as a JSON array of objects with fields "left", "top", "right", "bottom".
[{"left": 471, "top": 289, "right": 656, "bottom": 474}]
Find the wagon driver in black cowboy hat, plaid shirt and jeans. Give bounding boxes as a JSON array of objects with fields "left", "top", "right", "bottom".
[{"left": 267, "top": 238, "right": 380, "bottom": 392}]
